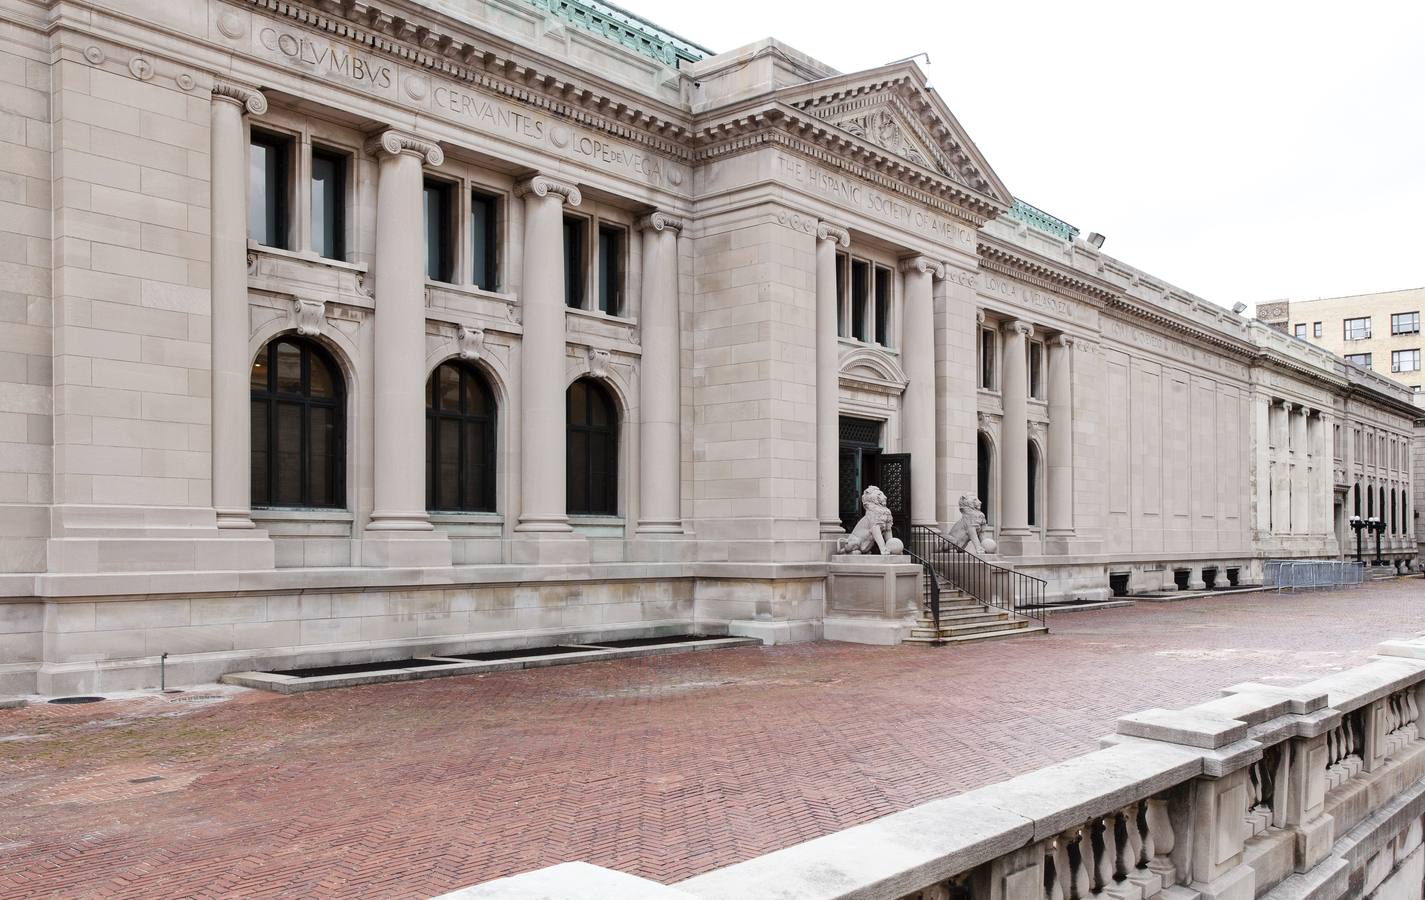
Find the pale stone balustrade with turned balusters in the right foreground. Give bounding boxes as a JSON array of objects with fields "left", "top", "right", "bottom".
[{"left": 447, "top": 639, "right": 1425, "bottom": 900}]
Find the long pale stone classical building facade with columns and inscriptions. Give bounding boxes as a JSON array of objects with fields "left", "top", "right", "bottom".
[{"left": 0, "top": 0, "right": 1415, "bottom": 692}]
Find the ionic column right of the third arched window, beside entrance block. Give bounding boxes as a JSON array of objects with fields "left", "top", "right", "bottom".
[{"left": 638, "top": 212, "right": 683, "bottom": 534}]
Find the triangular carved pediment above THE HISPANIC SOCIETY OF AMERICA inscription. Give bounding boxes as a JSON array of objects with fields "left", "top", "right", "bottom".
[{"left": 779, "top": 63, "right": 1015, "bottom": 206}]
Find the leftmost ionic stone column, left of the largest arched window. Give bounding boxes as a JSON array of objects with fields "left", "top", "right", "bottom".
[{"left": 208, "top": 81, "right": 266, "bottom": 528}]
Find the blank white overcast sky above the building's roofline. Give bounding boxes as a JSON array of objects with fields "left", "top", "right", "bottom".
[{"left": 638, "top": 0, "right": 1425, "bottom": 313}]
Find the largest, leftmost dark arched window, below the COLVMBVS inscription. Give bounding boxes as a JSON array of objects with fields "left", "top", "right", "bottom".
[{"left": 251, "top": 336, "right": 346, "bottom": 508}]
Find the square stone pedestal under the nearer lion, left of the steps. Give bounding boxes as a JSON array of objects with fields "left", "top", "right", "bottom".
[{"left": 822, "top": 554, "right": 921, "bottom": 644}]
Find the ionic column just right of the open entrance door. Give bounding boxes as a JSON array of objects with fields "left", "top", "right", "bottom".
[{"left": 901, "top": 256, "right": 945, "bottom": 525}]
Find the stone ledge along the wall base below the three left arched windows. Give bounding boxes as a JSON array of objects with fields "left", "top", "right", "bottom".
[{"left": 0, "top": 563, "right": 827, "bottom": 600}]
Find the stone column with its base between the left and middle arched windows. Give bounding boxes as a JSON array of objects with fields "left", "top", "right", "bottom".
[{"left": 362, "top": 131, "right": 450, "bottom": 565}]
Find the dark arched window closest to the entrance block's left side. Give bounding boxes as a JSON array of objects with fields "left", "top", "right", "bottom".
[{"left": 564, "top": 379, "right": 618, "bottom": 516}]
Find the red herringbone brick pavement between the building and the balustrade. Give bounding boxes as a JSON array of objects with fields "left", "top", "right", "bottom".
[{"left": 0, "top": 580, "right": 1425, "bottom": 897}]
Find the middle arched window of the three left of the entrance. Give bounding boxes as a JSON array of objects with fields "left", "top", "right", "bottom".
[{"left": 426, "top": 362, "right": 494, "bottom": 513}]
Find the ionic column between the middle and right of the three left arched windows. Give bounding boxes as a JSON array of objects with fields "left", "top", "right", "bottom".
[{"left": 514, "top": 175, "right": 581, "bottom": 533}]
